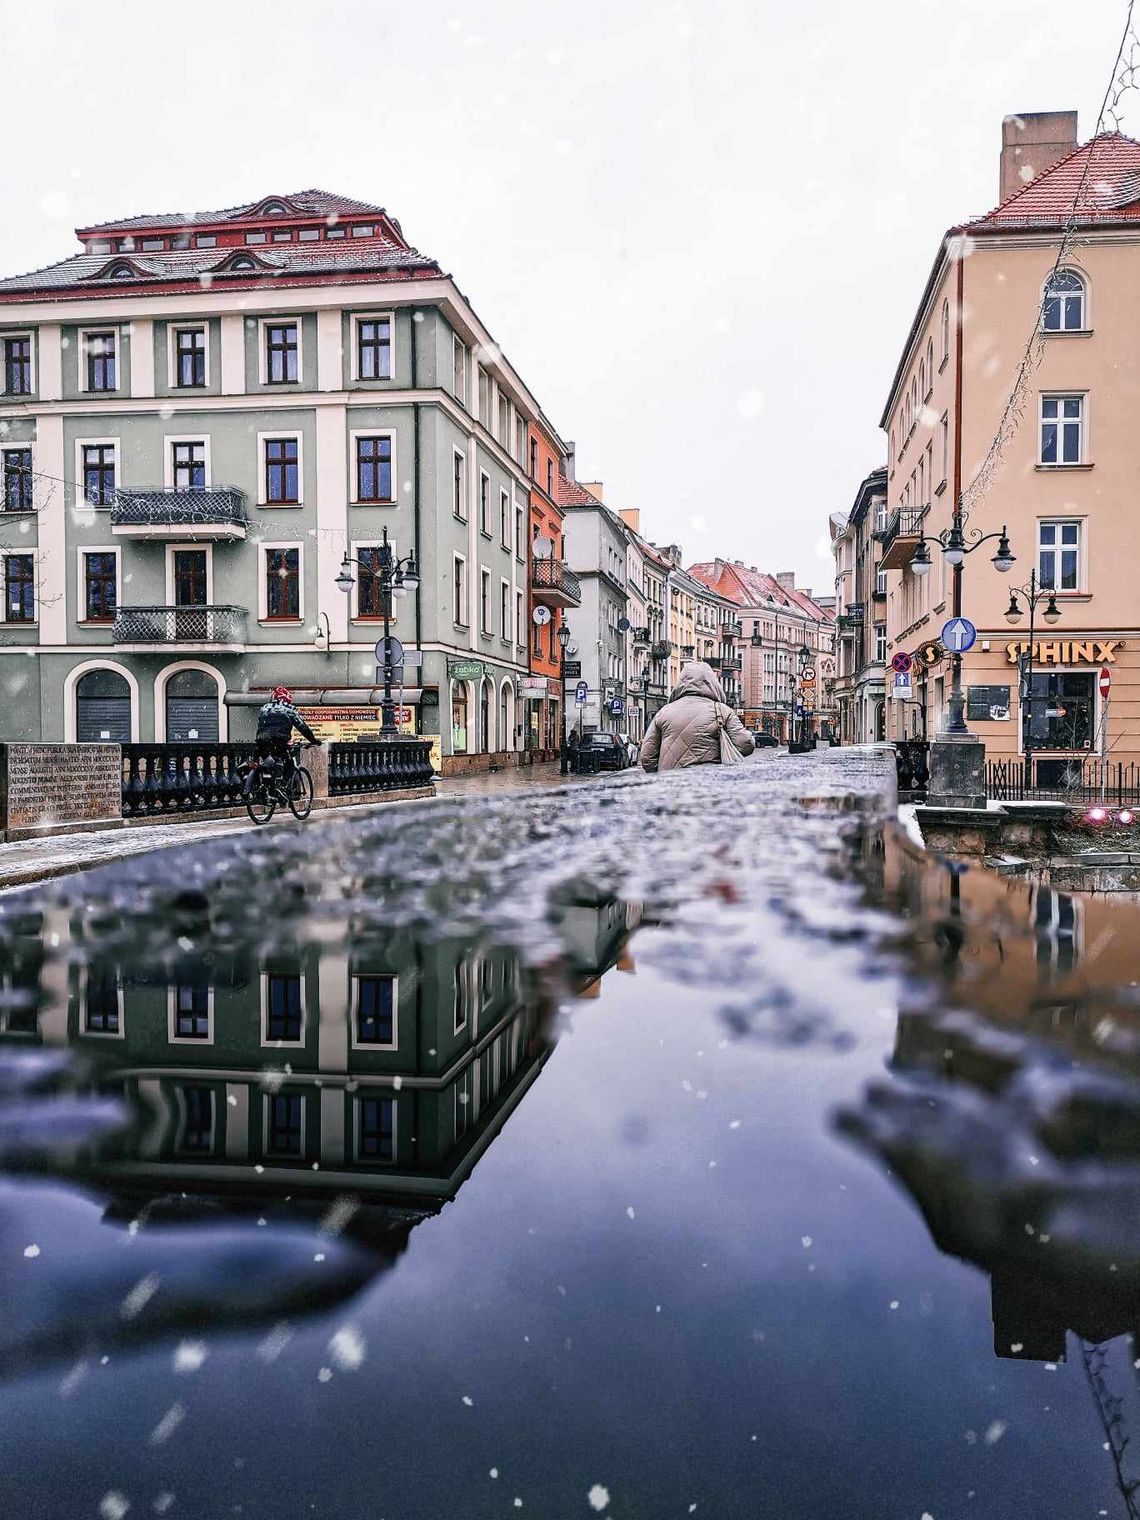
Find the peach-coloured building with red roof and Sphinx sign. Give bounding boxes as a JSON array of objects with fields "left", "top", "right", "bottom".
[{"left": 879, "top": 112, "right": 1140, "bottom": 781}]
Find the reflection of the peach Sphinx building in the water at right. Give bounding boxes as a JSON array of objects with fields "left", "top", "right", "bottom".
[{"left": 839, "top": 834, "right": 1140, "bottom": 1517}]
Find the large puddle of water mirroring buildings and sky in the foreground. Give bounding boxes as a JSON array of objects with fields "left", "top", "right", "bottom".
[{"left": 0, "top": 752, "right": 1140, "bottom": 1520}]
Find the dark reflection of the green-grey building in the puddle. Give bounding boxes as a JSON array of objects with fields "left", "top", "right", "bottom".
[{"left": 0, "top": 886, "right": 640, "bottom": 1366}]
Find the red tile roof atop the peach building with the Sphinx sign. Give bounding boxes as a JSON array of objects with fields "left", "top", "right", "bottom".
[{"left": 970, "top": 132, "right": 1140, "bottom": 231}]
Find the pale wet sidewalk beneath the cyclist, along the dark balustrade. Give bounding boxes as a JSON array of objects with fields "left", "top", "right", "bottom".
[{"left": 0, "top": 762, "right": 640, "bottom": 892}]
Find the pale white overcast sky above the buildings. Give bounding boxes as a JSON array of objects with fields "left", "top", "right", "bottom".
[{"left": 0, "top": 0, "right": 1137, "bottom": 590}]
